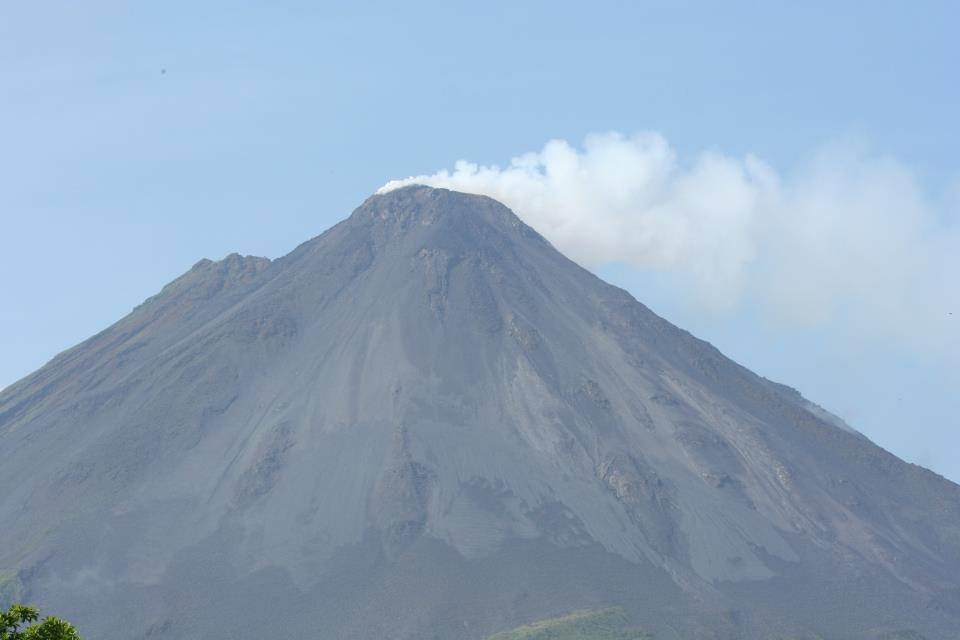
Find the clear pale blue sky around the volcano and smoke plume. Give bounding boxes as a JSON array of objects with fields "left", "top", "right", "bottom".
[{"left": 0, "top": 1, "right": 960, "bottom": 480}]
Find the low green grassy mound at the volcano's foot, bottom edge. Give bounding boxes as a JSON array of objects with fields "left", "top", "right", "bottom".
[{"left": 488, "top": 608, "right": 652, "bottom": 640}]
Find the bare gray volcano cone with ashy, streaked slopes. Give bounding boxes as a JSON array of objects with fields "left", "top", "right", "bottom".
[{"left": 0, "top": 187, "right": 960, "bottom": 640}]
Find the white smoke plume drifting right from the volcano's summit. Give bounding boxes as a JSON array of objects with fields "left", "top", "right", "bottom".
[{"left": 381, "top": 133, "right": 960, "bottom": 360}]
